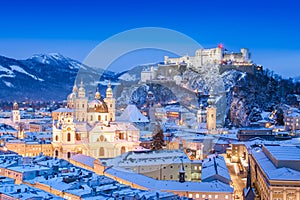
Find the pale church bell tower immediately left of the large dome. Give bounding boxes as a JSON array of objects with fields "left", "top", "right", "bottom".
[{"left": 75, "top": 81, "right": 88, "bottom": 122}]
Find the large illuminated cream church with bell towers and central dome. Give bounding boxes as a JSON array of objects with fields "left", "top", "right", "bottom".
[{"left": 52, "top": 82, "right": 140, "bottom": 159}]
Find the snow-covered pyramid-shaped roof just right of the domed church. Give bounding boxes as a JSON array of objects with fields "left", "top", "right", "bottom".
[{"left": 118, "top": 104, "right": 149, "bottom": 123}]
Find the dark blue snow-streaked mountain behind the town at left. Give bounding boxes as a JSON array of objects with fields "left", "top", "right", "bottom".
[{"left": 0, "top": 53, "right": 115, "bottom": 100}]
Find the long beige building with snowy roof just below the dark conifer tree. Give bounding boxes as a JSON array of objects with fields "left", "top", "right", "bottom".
[{"left": 100, "top": 150, "right": 201, "bottom": 181}]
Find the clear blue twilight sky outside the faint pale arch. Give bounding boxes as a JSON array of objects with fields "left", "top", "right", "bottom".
[{"left": 0, "top": 0, "right": 300, "bottom": 77}]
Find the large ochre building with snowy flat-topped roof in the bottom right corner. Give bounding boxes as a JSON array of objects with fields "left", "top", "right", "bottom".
[{"left": 249, "top": 144, "right": 300, "bottom": 200}]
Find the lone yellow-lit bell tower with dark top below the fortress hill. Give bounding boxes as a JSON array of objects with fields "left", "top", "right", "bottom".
[{"left": 206, "top": 90, "right": 217, "bottom": 131}]
